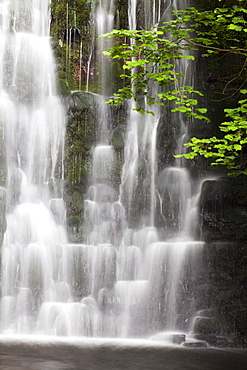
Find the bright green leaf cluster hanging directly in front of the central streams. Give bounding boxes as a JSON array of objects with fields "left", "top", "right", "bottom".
[{"left": 99, "top": 26, "right": 208, "bottom": 120}]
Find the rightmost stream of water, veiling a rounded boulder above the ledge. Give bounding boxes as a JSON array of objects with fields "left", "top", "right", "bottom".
[{"left": 157, "top": 0, "right": 200, "bottom": 239}]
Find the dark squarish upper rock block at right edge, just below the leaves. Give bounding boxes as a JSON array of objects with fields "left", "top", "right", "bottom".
[{"left": 200, "top": 177, "right": 247, "bottom": 242}]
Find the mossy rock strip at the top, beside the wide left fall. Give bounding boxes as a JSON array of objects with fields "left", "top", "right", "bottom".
[{"left": 51, "top": 0, "right": 91, "bottom": 95}]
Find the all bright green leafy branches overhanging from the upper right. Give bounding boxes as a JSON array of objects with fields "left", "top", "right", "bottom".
[{"left": 103, "top": 0, "right": 247, "bottom": 174}]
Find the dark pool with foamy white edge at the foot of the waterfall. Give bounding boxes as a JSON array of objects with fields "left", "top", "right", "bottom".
[{"left": 0, "top": 338, "right": 247, "bottom": 370}]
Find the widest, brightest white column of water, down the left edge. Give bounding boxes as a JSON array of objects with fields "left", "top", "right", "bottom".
[{"left": 0, "top": 0, "right": 67, "bottom": 333}]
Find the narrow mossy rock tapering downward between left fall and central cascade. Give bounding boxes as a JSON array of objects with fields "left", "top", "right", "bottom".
[{"left": 64, "top": 94, "right": 96, "bottom": 230}]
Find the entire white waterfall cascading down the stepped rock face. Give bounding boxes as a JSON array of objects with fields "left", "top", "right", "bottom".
[{"left": 0, "top": 0, "right": 205, "bottom": 337}]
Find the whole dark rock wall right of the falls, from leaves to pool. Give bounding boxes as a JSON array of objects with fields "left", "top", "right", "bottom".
[{"left": 198, "top": 177, "right": 247, "bottom": 335}]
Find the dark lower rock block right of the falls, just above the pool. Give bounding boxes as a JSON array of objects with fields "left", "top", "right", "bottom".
[{"left": 199, "top": 242, "right": 247, "bottom": 336}]
